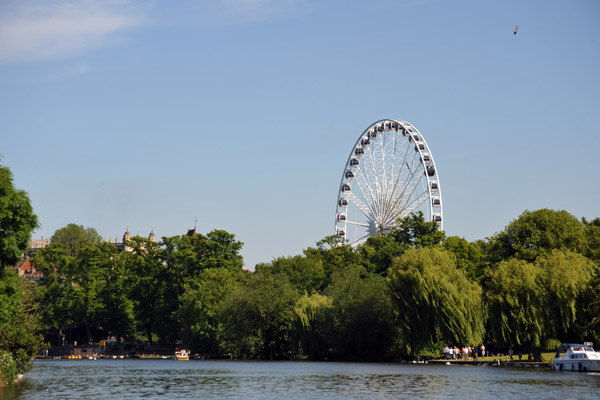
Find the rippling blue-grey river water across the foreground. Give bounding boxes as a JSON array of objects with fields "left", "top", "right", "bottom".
[{"left": 0, "top": 359, "right": 600, "bottom": 400}]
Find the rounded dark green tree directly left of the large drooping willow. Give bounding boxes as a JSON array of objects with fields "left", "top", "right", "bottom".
[{"left": 326, "top": 267, "right": 396, "bottom": 360}]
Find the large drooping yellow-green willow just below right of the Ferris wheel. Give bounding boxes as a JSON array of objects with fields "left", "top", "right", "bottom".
[{"left": 388, "top": 247, "right": 484, "bottom": 356}]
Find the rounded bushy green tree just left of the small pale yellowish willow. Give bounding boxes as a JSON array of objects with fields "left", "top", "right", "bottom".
[{"left": 219, "top": 273, "right": 299, "bottom": 360}]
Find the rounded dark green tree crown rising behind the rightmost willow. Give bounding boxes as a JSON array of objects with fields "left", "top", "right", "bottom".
[{"left": 488, "top": 208, "right": 587, "bottom": 263}]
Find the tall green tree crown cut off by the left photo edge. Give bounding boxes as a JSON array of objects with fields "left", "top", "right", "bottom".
[{"left": 0, "top": 165, "right": 38, "bottom": 268}]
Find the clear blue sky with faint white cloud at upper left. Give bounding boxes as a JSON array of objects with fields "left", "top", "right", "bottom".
[{"left": 0, "top": 0, "right": 600, "bottom": 268}]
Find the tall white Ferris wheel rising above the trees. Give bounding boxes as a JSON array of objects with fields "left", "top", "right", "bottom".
[{"left": 335, "top": 119, "right": 443, "bottom": 246}]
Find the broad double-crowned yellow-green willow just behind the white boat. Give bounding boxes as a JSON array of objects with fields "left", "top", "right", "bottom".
[{"left": 486, "top": 250, "right": 598, "bottom": 348}]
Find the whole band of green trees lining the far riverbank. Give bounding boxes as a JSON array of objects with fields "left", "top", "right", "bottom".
[{"left": 0, "top": 162, "right": 600, "bottom": 384}]
